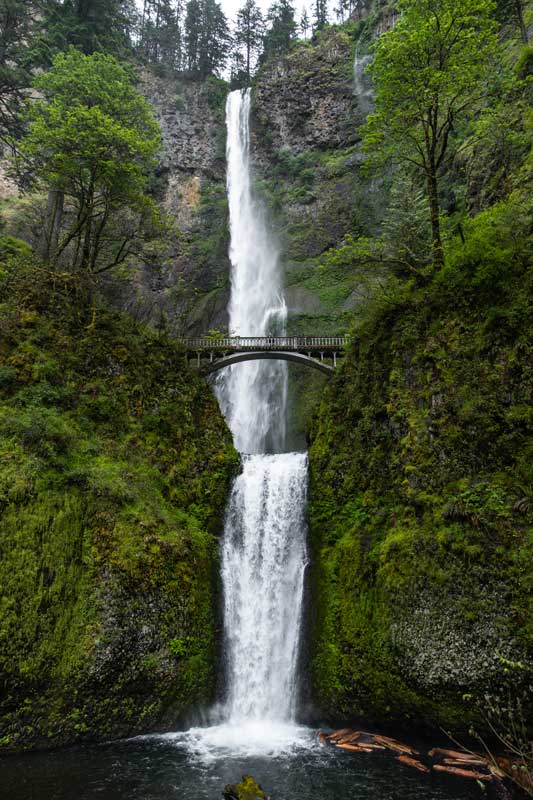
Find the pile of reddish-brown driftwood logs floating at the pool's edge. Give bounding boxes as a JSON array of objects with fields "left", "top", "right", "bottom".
[{"left": 318, "top": 728, "right": 505, "bottom": 781}]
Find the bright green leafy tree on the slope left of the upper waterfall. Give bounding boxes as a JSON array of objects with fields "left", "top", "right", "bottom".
[{"left": 20, "top": 49, "right": 160, "bottom": 274}]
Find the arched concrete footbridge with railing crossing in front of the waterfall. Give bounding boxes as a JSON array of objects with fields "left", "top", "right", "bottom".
[{"left": 179, "top": 336, "right": 348, "bottom": 375}]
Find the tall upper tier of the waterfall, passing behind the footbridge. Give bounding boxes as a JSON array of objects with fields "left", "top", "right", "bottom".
[{"left": 217, "top": 89, "right": 287, "bottom": 453}]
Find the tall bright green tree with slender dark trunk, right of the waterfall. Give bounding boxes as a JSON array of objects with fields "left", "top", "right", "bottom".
[{"left": 365, "top": 0, "right": 497, "bottom": 267}]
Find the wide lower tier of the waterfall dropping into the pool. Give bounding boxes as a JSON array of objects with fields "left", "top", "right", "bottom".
[{"left": 222, "top": 453, "right": 307, "bottom": 724}]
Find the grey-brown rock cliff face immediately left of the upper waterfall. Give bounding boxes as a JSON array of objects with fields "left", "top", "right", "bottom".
[{"left": 114, "top": 72, "right": 229, "bottom": 335}]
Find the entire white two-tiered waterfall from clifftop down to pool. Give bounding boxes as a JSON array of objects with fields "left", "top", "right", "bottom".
[{"left": 216, "top": 90, "right": 307, "bottom": 727}]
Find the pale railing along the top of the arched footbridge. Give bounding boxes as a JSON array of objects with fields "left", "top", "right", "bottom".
[{"left": 179, "top": 336, "right": 348, "bottom": 351}]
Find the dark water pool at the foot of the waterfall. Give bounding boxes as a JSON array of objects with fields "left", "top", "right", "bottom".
[{"left": 0, "top": 733, "right": 482, "bottom": 800}]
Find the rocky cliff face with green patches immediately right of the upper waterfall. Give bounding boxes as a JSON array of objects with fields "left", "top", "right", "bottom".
[{"left": 253, "top": 28, "right": 378, "bottom": 334}]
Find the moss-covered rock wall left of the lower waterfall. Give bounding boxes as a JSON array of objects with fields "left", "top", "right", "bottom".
[{"left": 0, "top": 261, "right": 238, "bottom": 748}]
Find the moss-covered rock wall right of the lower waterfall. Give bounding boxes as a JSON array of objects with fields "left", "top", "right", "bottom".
[{"left": 310, "top": 242, "right": 533, "bottom": 731}]
